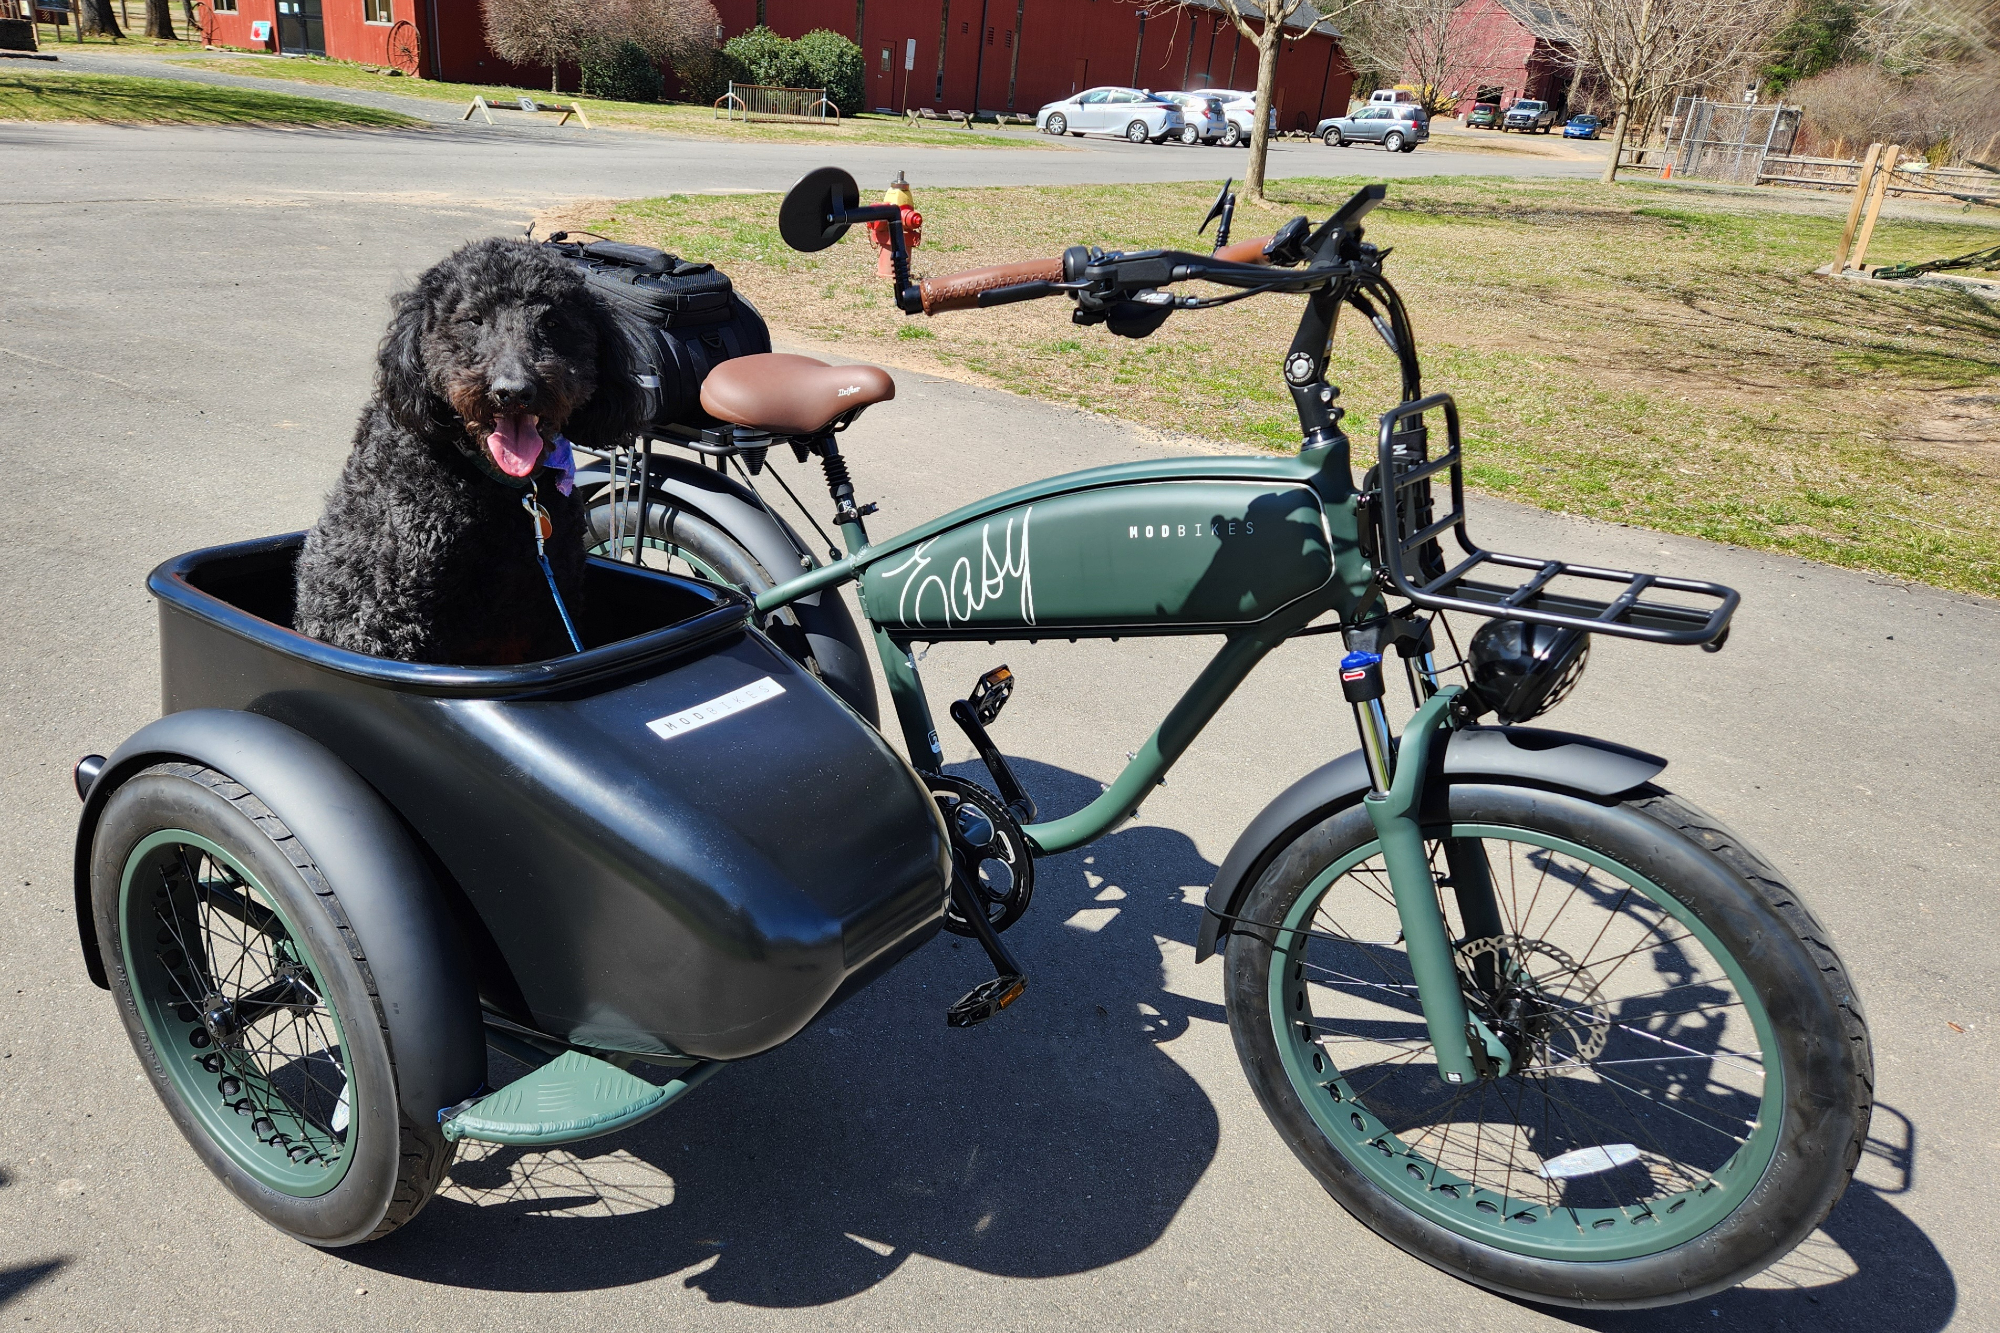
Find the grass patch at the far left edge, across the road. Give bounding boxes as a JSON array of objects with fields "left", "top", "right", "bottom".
[{"left": 0, "top": 70, "right": 422, "bottom": 128}]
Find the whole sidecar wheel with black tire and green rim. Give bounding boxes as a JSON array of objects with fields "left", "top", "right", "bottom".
[{"left": 90, "top": 763, "right": 452, "bottom": 1247}]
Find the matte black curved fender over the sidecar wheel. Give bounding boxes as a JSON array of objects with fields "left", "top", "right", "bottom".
[{"left": 76, "top": 709, "right": 486, "bottom": 1123}]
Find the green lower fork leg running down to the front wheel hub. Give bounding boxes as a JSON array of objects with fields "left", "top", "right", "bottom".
[{"left": 1362, "top": 685, "right": 1514, "bottom": 1085}]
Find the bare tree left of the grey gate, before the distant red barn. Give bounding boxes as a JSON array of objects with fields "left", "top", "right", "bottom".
[{"left": 1564, "top": 0, "right": 1784, "bottom": 184}]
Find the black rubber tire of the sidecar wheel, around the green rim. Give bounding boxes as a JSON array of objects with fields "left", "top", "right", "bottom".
[{"left": 92, "top": 763, "right": 454, "bottom": 1247}]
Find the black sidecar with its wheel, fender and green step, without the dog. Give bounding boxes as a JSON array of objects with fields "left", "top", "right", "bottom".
[{"left": 76, "top": 534, "right": 950, "bottom": 1245}]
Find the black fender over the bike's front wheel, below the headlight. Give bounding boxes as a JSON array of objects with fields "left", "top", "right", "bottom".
[{"left": 1194, "top": 727, "right": 1666, "bottom": 963}]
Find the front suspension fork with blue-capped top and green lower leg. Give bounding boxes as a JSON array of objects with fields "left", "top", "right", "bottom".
[{"left": 1340, "top": 652, "right": 1512, "bottom": 1085}]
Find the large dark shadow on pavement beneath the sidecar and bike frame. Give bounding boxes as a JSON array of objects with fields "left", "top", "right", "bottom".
[{"left": 342, "top": 763, "right": 1222, "bottom": 1307}]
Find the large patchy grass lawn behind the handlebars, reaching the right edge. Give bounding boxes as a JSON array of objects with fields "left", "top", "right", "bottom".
[{"left": 572, "top": 178, "right": 2000, "bottom": 594}]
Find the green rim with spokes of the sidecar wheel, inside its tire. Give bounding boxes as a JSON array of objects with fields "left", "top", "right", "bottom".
[{"left": 118, "top": 829, "right": 360, "bottom": 1199}]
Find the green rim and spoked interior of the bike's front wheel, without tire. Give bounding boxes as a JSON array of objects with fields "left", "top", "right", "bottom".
[{"left": 1268, "top": 825, "right": 1784, "bottom": 1263}]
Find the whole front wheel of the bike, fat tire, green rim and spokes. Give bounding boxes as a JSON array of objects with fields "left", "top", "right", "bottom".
[{"left": 1224, "top": 783, "right": 1874, "bottom": 1307}]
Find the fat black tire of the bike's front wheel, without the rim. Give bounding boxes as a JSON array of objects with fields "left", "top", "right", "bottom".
[{"left": 1224, "top": 781, "right": 1874, "bottom": 1309}]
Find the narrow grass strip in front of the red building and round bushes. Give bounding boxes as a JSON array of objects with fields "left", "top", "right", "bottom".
[{"left": 172, "top": 56, "right": 1056, "bottom": 148}]
